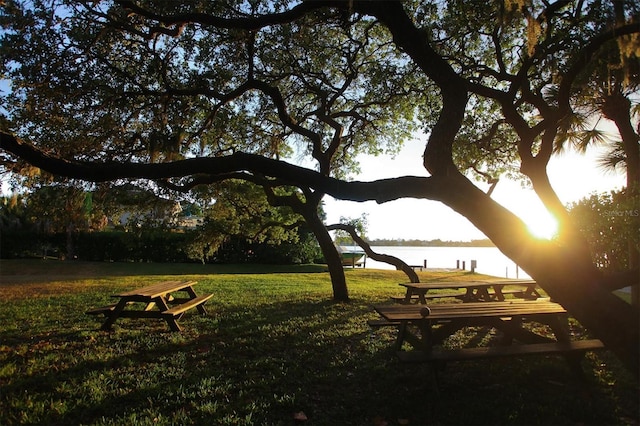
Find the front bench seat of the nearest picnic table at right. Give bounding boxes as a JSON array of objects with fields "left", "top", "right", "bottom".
[{"left": 398, "top": 339, "right": 604, "bottom": 362}]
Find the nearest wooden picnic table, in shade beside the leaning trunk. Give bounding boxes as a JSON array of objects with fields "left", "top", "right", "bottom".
[{"left": 375, "top": 300, "right": 603, "bottom": 369}]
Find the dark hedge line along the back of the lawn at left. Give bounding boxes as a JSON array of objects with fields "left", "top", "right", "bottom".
[{"left": 0, "top": 230, "right": 323, "bottom": 265}]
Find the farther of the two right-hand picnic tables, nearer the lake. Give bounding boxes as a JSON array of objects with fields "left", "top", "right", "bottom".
[{"left": 396, "top": 280, "right": 540, "bottom": 304}]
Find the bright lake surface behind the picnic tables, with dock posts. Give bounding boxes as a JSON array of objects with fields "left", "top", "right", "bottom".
[{"left": 366, "top": 246, "right": 531, "bottom": 279}]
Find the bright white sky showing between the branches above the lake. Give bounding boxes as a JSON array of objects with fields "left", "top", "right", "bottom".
[{"left": 324, "top": 134, "right": 626, "bottom": 241}]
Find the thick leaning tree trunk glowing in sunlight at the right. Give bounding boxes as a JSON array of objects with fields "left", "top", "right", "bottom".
[{"left": 443, "top": 175, "right": 640, "bottom": 377}]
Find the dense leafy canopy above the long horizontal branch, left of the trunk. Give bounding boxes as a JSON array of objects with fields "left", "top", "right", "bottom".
[{"left": 2, "top": 2, "right": 424, "bottom": 183}]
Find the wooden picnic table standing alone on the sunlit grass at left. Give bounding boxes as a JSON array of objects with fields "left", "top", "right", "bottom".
[{"left": 87, "top": 281, "right": 212, "bottom": 331}]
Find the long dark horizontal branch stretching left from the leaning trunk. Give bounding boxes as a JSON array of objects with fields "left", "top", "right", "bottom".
[{"left": 0, "top": 131, "right": 452, "bottom": 203}]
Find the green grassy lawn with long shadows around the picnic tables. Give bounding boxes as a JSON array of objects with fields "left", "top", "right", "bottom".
[{"left": 0, "top": 260, "right": 639, "bottom": 426}]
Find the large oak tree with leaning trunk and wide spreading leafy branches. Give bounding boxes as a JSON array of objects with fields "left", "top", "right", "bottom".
[{"left": 0, "top": 0, "right": 640, "bottom": 374}]
